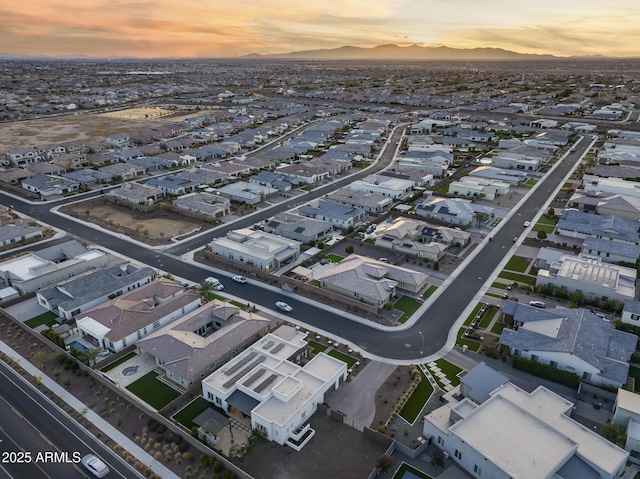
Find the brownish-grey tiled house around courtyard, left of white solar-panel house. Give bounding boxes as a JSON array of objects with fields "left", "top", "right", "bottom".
[{"left": 137, "top": 300, "right": 276, "bottom": 389}]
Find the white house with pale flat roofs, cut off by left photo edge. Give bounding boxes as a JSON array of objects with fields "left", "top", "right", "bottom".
[{"left": 0, "top": 240, "right": 107, "bottom": 295}]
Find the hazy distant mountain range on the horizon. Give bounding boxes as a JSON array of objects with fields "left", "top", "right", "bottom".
[{"left": 241, "top": 44, "right": 559, "bottom": 61}]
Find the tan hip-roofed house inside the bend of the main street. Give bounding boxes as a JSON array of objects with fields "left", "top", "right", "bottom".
[{"left": 315, "top": 254, "right": 427, "bottom": 309}]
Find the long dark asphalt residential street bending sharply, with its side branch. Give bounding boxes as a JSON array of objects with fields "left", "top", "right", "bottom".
[{"left": 0, "top": 133, "right": 590, "bottom": 361}]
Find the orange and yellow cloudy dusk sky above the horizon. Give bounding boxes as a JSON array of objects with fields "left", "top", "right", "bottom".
[{"left": 5, "top": 0, "right": 640, "bottom": 57}]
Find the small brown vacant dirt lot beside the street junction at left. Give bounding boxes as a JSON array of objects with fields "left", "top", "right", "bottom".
[{"left": 60, "top": 198, "right": 213, "bottom": 245}]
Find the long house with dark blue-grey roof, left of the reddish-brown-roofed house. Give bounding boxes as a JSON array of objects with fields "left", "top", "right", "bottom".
[{"left": 36, "top": 263, "right": 156, "bottom": 319}]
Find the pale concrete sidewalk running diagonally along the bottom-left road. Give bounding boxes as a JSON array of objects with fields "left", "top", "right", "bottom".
[{"left": 0, "top": 341, "right": 179, "bottom": 479}]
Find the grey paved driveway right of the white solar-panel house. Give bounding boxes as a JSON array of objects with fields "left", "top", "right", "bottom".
[{"left": 328, "top": 361, "right": 396, "bottom": 427}]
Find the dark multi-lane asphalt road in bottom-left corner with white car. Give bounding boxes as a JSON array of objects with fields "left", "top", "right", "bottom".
[{"left": 0, "top": 363, "right": 142, "bottom": 479}]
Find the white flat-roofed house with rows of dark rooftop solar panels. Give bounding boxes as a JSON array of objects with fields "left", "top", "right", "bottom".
[{"left": 202, "top": 326, "right": 347, "bottom": 451}]
